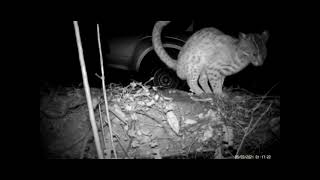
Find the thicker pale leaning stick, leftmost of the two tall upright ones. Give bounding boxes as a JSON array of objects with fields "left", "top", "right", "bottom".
[{"left": 73, "top": 21, "right": 103, "bottom": 159}]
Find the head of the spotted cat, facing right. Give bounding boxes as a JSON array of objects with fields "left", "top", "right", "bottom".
[{"left": 239, "top": 31, "right": 269, "bottom": 66}]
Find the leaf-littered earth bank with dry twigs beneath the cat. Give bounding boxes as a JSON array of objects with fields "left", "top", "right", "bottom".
[{"left": 40, "top": 82, "right": 280, "bottom": 159}]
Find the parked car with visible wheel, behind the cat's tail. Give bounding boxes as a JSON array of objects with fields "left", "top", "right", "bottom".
[{"left": 103, "top": 21, "right": 193, "bottom": 88}]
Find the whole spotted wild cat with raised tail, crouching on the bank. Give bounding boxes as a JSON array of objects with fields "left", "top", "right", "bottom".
[{"left": 152, "top": 21, "right": 269, "bottom": 97}]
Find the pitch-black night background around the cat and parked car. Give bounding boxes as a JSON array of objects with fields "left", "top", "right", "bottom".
[{"left": 39, "top": 18, "right": 280, "bottom": 95}]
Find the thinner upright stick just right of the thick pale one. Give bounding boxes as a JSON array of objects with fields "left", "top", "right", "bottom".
[{"left": 97, "top": 24, "right": 118, "bottom": 159}]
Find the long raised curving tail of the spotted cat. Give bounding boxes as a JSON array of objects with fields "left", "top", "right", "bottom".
[{"left": 152, "top": 21, "right": 177, "bottom": 70}]
